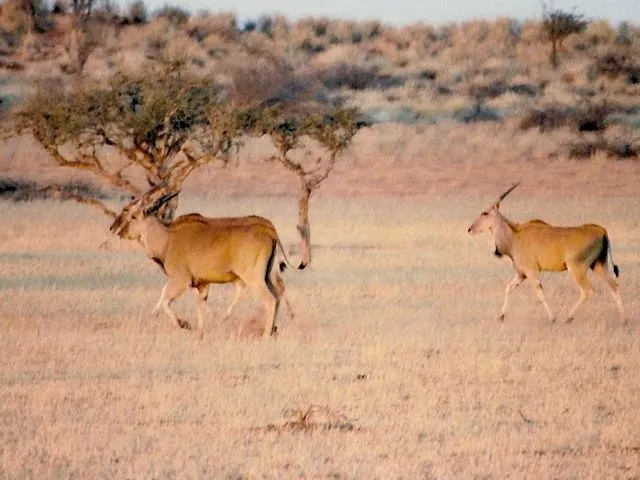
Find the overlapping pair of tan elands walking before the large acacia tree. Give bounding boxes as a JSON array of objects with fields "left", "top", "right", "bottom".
[{"left": 111, "top": 192, "right": 306, "bottom": 338}]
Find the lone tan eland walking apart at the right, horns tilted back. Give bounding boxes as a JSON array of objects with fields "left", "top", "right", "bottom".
[{"left": 469, "top": 184, "right": 624, "bottom": 321}]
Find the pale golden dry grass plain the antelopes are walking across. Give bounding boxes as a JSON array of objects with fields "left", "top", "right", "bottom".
[{"left": 0, "top": 192, "right": 640, "bottom": 478}]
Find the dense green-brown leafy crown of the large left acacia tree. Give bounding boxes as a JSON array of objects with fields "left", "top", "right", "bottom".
[{"left": 18, "top": 68, "right": 228, "bottom": 155}]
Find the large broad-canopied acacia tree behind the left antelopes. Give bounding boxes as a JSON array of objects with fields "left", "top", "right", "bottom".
[{"left": 16, "top": 65, "right": 245, "bottom": 220}]
